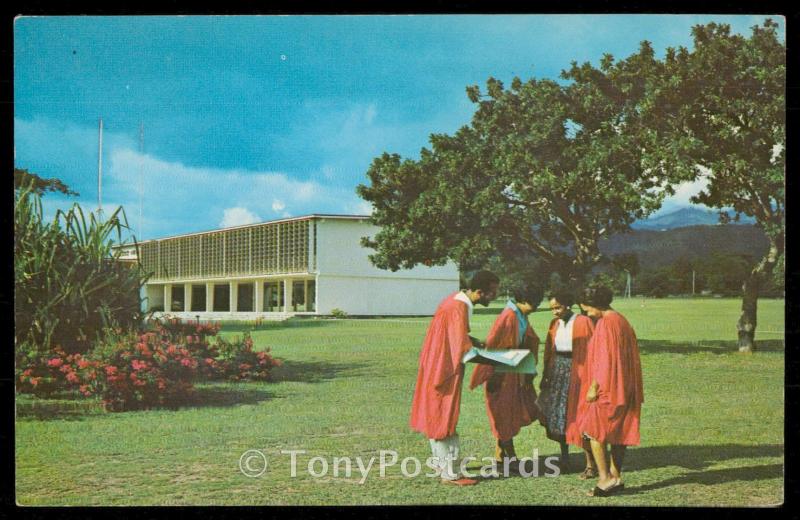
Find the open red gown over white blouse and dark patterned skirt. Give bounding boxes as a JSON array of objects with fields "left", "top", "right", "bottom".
[{"left": 542, "top": 314, "right": 594, "bottom": 446}]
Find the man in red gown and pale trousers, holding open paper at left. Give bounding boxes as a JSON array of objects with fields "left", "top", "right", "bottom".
[{"left": 410, "top": 271, "right": 500, "bottom": 486}]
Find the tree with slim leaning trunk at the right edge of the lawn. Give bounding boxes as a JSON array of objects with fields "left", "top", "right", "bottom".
[{"left": 628, "top": 20, "right": 786, "bottom": 351}]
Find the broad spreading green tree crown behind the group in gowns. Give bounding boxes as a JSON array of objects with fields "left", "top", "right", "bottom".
[{"left": 358, "top": 52, "right": 665, "bottom": 284}]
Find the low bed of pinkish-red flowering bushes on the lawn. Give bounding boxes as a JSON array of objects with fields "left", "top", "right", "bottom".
[{"left": 17, "top": 320, "right": 280, "bottom": 411}]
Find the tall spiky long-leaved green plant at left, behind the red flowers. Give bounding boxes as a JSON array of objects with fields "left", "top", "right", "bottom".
[{"left": 14, "top": 179, "right": 150, "bottom": 361}]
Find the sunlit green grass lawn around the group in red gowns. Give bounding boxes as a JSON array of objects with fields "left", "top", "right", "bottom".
[{"left": 16, "top": 299, "right": 784, "bottom": 506}]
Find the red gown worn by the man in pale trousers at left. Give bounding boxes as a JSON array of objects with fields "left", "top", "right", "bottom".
[{"left": 410, "top": 293, "right": 472, "bottom": 439}]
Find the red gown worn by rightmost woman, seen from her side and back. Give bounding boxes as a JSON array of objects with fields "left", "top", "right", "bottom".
[{"left": 578, "top": 311, "right": 644, "bottom": 446}]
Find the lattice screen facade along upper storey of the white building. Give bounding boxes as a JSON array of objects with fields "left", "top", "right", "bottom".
[{"left": 139, "top": 219, "right": 316, "bottom": 282}]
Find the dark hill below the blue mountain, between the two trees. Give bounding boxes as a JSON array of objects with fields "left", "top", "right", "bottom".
[{"left": 600, "top": 224, "right": 768, "bottom": 268}]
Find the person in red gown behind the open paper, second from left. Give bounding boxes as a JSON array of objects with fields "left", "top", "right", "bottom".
[{"left": 469, "top": 287, "right": 543, "bottom": 465}]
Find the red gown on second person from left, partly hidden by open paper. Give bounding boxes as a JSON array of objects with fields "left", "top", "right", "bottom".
[{"left": 469, "top": 308, "right": 541, "bottom": 441}]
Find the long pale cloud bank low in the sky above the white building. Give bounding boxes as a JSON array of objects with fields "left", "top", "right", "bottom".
[{"left": 14, "top": 116, "right": 432, "bottom": 240}]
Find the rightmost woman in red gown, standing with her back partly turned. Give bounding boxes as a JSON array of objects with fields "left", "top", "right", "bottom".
[{"left": 578, "top": 287, "right": 644, "bottom": 496}]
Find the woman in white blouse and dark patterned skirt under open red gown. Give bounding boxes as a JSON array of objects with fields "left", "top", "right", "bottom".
[{"left": 539, "top": 290, "right": 597, "bottom": 480}]
